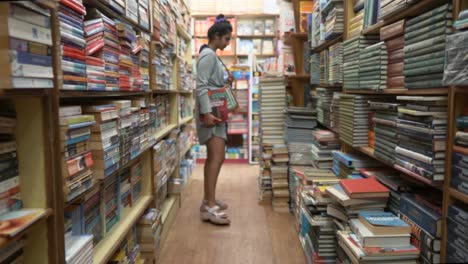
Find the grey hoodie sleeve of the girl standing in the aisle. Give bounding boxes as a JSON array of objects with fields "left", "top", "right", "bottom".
[{"left": 197, "top": 53, "right": 217, "bottom": 114}]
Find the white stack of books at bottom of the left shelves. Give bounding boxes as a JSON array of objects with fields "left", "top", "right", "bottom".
[{"left": 65, "top": 235, "right": 93, "bottom": 264}]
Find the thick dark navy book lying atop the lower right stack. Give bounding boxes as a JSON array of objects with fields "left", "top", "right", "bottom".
[{"left": 400, "top": 195, "right": 441, "bottom": 237}]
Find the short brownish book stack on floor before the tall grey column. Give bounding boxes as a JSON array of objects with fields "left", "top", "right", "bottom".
[{"left": 271, "top": 165, "right": 289, "bottom": 212}]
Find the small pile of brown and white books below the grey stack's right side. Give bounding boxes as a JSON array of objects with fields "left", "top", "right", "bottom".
[{"left": 311, "top": 130, "right": 341, "bottom": 169}]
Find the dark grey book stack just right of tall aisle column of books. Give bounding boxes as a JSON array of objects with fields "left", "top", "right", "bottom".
[{"left": 284, "top": 106, "right": 317, "bottom": 143}]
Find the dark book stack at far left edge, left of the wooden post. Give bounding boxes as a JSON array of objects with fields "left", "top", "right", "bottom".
[{"left": 0, "top": 107, "right": 23, "bottom": 214}]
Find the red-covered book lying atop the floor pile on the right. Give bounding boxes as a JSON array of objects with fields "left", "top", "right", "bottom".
[{"left": 340, "top": 178, "right": 390, "bottom": 198}]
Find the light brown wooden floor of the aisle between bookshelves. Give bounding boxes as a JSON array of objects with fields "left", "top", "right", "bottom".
[{"left": 158, "top": 164, "right": 305, "bottom": 264}]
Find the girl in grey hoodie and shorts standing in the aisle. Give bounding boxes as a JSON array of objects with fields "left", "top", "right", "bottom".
[{"left": 195, "top": 14, "right": 233, "bottom": 225}]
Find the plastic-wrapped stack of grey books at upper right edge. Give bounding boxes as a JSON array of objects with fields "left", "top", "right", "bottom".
[{"left": 444, "top": 30, "right": 468, "bottom": 85}]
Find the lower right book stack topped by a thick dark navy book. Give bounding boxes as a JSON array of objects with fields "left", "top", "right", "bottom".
[{"left": 400, "top": 193, "right": 442, "bottom": 263}]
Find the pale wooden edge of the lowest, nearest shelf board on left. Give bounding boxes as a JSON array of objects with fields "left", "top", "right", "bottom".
[{"left": 93, "top": 195, "right": 153, "bottom": 264}]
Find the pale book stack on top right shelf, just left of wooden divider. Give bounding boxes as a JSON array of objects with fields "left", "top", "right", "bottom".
[{"left": 322, "top": 0, "right": 344, "bottom": 40}]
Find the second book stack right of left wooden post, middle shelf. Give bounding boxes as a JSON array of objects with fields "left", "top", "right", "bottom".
[{"left": 83, "top": 104, "right": 120, "bottom": 179}]
